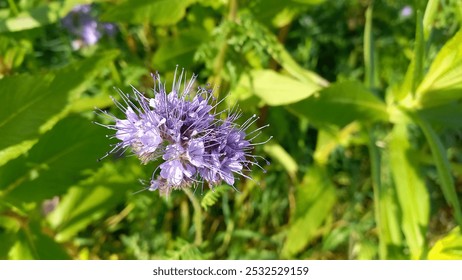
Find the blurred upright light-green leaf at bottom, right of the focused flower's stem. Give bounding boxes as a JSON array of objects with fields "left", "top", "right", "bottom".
[{"left": 281, "top": 166, "right": 336, "bottom": 258}]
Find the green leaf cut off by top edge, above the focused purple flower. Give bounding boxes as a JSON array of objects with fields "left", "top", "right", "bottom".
[{"left": 101, "top": 0, "right": 196, "bottom": 25}]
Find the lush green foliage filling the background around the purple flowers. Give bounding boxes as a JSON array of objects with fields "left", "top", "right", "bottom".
[{"left": 0, "top": 0, "right": 462, "bottom": 259}]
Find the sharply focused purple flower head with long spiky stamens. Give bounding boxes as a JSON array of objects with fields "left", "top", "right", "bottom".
[{"left": 97, "top": 68, "right": 271, "bottom": 195}]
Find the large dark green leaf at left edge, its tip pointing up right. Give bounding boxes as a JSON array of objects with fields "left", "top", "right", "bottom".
[{"left": 0, "top": 52, "right": 117, "bottom": 155}]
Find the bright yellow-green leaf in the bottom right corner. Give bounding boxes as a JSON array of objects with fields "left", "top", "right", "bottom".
[{"left": 427, "top": 227, "right": 462, "bottom": 260}]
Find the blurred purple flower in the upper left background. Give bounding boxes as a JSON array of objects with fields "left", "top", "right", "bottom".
[{"left": 61, "top": 5, "right": 116, "bottom": 49}]
